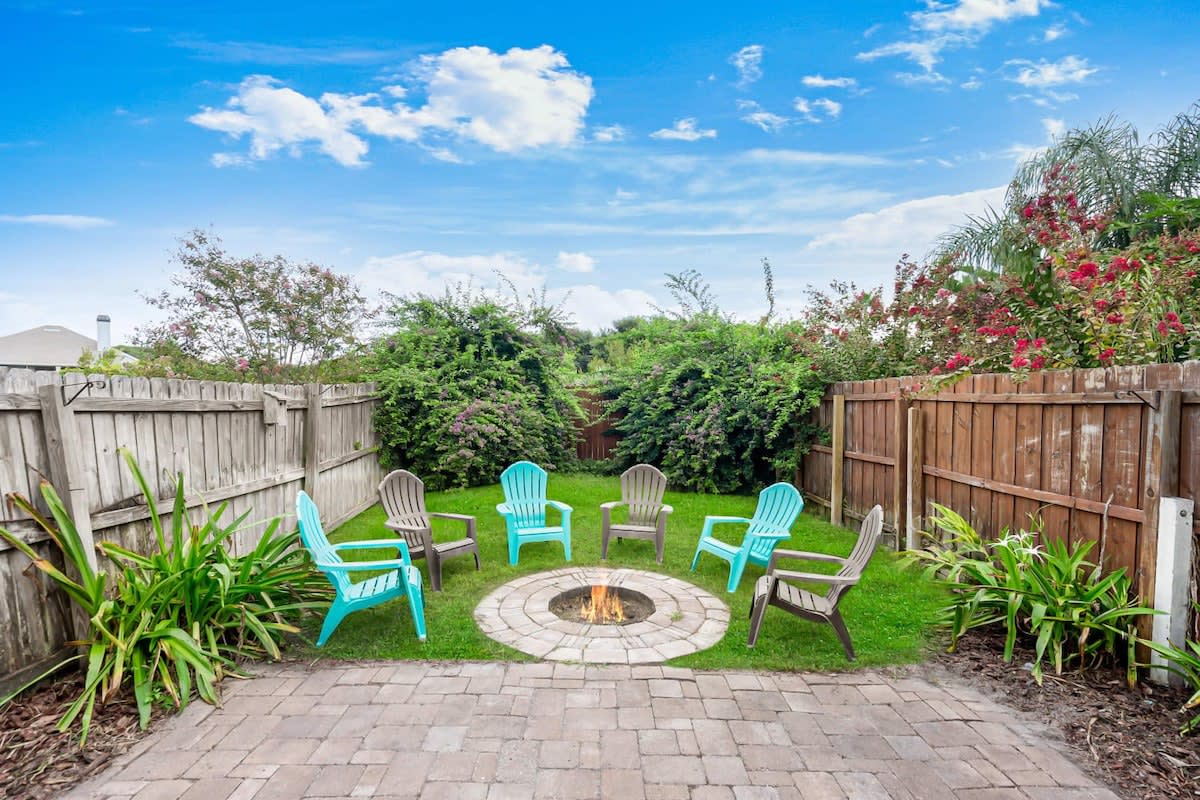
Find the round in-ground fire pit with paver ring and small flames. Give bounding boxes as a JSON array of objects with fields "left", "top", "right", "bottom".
[{"left": 475, "top": 567, "right": 730, "bottom": 664}]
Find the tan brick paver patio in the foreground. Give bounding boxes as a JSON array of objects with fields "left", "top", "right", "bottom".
[{"left": 65, "top": 663, "right": 1116, "bottom": 800}]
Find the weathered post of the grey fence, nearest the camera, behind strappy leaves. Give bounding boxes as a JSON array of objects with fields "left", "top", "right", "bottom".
[{"left": 37, "top": 383, "right": 97, "bottom": 639}]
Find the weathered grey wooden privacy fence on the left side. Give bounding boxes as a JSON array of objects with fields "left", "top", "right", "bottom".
[{"left": 0, "top": 368, "right": 382, "bottom": 690}]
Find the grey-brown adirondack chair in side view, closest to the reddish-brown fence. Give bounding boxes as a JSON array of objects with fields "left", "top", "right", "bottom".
[{"left": 746, "top": 506, "right": 883, "bottom": 661}]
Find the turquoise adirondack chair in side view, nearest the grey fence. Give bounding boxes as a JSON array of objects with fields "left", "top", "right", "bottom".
[{"left": 296, "top": 492, "right": 425, "bottom": 648}]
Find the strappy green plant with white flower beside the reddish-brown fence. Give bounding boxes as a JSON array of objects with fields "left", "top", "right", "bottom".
[{"left": 910, "top": 504, "right": 1153, "bottom": 684}]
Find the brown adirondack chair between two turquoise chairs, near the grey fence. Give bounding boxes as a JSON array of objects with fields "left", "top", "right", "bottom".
[{"left": 379, "top": 469, "right": 479, "bottom": 591}]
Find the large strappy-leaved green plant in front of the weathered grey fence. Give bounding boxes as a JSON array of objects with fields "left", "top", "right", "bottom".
[{"left": 0, "top": 451, "right": 329, "bottom": 744}]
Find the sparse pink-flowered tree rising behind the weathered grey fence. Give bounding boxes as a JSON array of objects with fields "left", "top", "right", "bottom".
[{"left": 138, "top": 229, "right": 371, "bottom": 380}]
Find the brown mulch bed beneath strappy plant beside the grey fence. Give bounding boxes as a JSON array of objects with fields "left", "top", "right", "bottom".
[{"left": 0, "top": 674, "right": 146, "bottom": 800}]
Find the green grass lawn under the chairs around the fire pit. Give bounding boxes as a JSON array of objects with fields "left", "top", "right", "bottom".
[{"left": 301, "top": 474, "right": 946, "bottom": 670}]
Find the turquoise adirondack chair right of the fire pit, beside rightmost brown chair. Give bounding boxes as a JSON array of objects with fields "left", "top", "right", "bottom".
[{"left": 691, "top": 482, "right": 804, "bottom": 591}]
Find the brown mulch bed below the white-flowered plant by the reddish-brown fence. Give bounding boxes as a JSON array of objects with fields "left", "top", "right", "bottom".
[{"left": 929, "top": 631, "right": 1200, "bottom": 800}]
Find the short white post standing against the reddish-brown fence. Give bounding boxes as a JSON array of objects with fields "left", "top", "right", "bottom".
[{"left": 1150, "top": 498, "right": 1194, "bottom": 686}]
